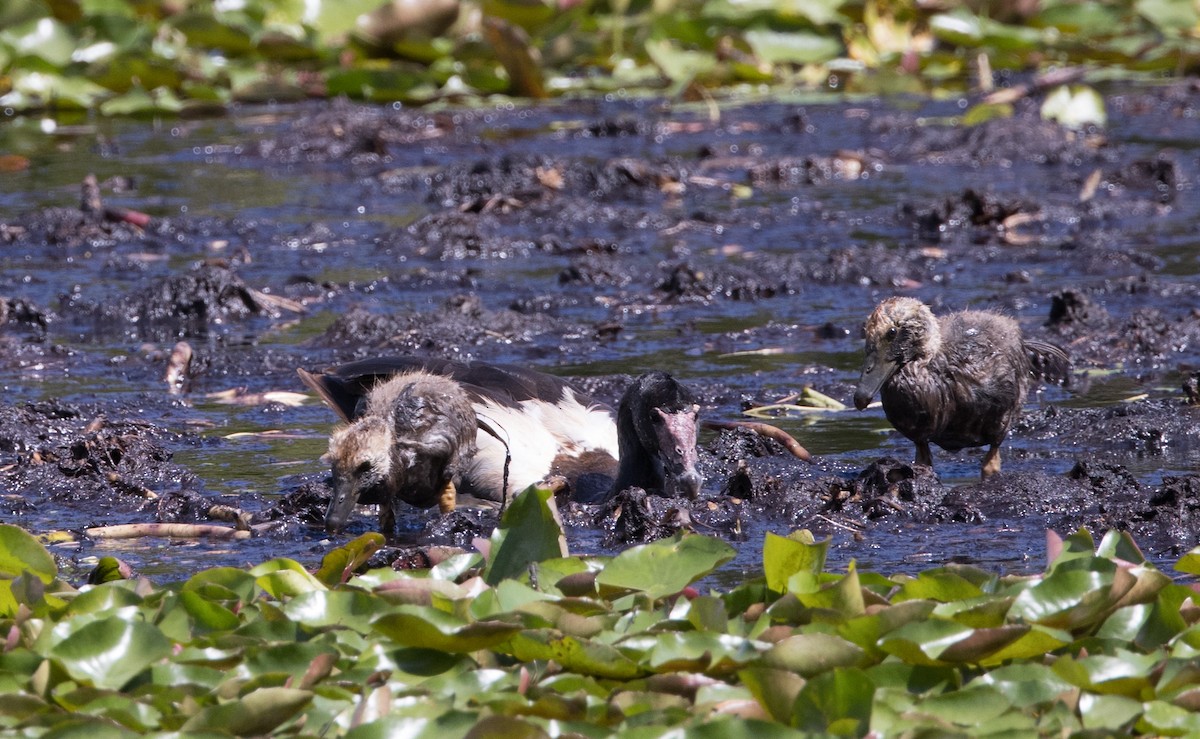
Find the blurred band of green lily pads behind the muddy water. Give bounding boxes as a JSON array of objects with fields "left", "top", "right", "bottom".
[{"left": 0, "top": 0, "right": 1200, "bottom": 115}]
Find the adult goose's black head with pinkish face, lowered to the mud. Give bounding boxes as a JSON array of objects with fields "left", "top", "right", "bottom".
[{"left": 613, "top": 372, "right": 704, "bottom": 498}]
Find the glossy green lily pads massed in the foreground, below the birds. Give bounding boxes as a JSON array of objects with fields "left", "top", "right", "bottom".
[{"left": 0, "top": 506, "right": 1200, "bottom": 738}]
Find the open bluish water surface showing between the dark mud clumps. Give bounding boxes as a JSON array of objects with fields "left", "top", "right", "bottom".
[{"left": 0, "top": 93, "right": 1200, "bottom": 577}]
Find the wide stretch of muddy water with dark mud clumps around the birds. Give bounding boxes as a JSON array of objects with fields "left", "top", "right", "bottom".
[{"left": 0, "top": 86, "right": 1200, "bottom": 577}]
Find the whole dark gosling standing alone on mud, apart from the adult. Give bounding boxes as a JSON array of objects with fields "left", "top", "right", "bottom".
[{"left": 854, "top": 298, "right": 1070, "bottom": 477}]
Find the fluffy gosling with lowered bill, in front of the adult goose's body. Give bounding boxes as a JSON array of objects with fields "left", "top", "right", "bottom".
[{"left": 301, "top": 372, "right": 475, "bottom": 533}]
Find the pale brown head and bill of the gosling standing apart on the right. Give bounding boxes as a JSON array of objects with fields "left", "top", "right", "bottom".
[{"left": 854, "top": 298, "right": 942, "bottom": 410}]
